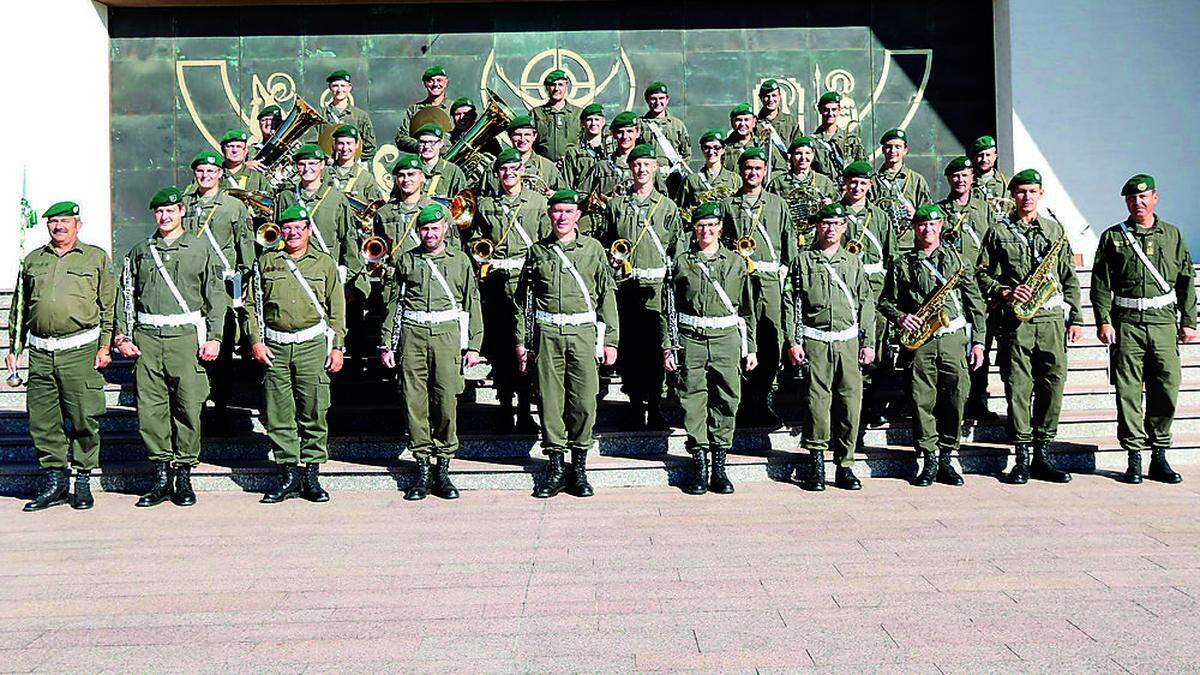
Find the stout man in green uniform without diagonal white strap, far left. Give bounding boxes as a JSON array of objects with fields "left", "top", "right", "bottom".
[{"left": 5, "top": 202, "right": 115, "bottom": 510}]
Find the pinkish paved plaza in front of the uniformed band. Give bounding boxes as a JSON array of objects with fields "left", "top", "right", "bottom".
[{"left": 0, "top": 467, "right": 1200, "bottom": 673}]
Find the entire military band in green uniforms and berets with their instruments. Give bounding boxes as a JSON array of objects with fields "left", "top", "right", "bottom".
[{"left": 6, "top": 66, "right": 1196, "bottom": 510}]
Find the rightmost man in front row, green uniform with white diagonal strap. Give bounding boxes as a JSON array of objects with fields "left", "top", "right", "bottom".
[{"left": 1091, "top": 173, "right": 1196, "bottom": 483}]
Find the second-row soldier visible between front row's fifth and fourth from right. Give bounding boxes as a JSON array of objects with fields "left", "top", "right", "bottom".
[{"left": 721, "top": 148, "right": 796, "bottom": 428}]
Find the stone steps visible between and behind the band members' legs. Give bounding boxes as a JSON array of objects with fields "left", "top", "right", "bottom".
[{"left": 0, "top": 266, "right": 1200, "bottom": 495}]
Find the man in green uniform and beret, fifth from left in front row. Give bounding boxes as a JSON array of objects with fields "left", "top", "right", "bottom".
[{"left": 516, "top": 190, "right": 620, "bottom": 498}]
